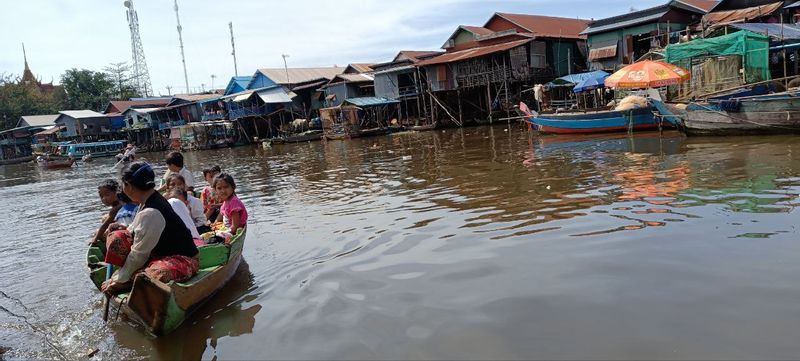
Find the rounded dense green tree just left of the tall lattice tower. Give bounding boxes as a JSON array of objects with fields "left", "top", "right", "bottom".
[{"left": 61, "top": 68, "right": 114, "bottom": 111}]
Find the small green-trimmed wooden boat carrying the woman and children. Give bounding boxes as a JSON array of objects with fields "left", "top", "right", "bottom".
[{"left": 87, "top": 229, "right": 247, "bottom": 336}]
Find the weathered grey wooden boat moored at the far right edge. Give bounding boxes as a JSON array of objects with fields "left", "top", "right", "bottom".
[{"left": 682, "top": 90, "right": 800, "bottom": 136}]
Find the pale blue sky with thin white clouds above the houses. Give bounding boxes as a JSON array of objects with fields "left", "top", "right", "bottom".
[{"left": 0, "top": 0, "right": 665, "bottom": 95}]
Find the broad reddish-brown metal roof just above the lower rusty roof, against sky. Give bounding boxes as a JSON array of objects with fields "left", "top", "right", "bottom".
[{"left": 484, "top": 13, "right": 591, "bottom": 39}]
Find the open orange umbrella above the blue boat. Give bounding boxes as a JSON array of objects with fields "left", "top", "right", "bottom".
[{"left": 606, "top": 60, "right": 691, "bottom": 89}]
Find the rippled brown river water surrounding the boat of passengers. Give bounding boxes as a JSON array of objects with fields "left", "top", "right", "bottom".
[{"left": 0, "top": 125, "right": 800, "bottom": 359}]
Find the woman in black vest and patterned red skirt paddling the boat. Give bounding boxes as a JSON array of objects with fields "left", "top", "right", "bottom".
[{"left": 101, "top": 162, "right": 200, "bottom": 294}]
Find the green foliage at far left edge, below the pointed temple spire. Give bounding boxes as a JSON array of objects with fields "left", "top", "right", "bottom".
[{"left": 0, "top": 74, "right": 65, "bottom": 129}]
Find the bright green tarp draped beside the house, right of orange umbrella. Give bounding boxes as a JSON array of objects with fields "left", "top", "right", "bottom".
[{"left": 664, "top": 31, "right": 771, "bottom": 83}]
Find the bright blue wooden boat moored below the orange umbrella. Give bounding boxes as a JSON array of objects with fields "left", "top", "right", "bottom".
[{"left": 523, "top": 107, "right": 658, "bottom": 134}]
